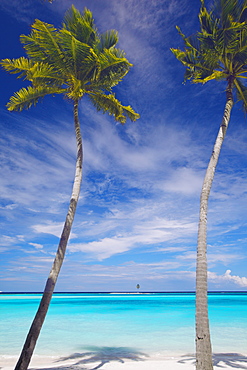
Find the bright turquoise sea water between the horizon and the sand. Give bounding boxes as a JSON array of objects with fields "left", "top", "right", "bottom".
[{"left": 0, "top": 292, "right": 247, "bottom": 356}]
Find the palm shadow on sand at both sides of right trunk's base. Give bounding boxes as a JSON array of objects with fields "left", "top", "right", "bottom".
[{"left": 178, "top": 353, "right": 247, "bottom": 370}]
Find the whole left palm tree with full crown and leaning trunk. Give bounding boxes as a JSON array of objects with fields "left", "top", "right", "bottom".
[{"left": 1, "top": 6, "right": 139, "bottom": 370}]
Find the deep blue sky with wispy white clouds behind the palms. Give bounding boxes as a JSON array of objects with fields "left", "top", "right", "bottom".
[{"left": 0, "top": 0, "right": 247, "bottom": 292}]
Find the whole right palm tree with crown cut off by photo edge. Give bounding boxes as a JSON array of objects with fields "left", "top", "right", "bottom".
[{"left": 171, "top": 0, "right": 247, "bottom": 370}]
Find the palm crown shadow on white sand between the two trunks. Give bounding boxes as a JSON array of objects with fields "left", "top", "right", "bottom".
[{"left": 30, "top": 346, "right": 148, "bottom": 370}]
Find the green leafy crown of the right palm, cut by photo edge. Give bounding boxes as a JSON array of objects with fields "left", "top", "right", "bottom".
[{"left": 171, "top": 0, "right": 247, "bottom": 109}]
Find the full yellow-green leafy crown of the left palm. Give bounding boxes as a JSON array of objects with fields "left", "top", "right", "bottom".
[{"left": 1, "top": 6, "right": 139, "bottom": 123}]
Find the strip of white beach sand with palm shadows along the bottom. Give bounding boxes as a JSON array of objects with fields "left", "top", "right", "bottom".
[{"left": 0, "top": 353, "right": 247, "bottom": 370}]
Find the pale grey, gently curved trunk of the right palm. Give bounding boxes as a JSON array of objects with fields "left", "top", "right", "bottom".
[{"left": 196, "top": 77, "right": 233, "bottom": 370}]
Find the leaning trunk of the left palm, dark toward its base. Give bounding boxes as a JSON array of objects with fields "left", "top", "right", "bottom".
[{"left": 15, "top": 101, "right": 83, "bottom": 370}]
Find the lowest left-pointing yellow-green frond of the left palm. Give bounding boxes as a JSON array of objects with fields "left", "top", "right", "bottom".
[{"left": 7, "top": 86, "right": 66, "bottom": 111}]
